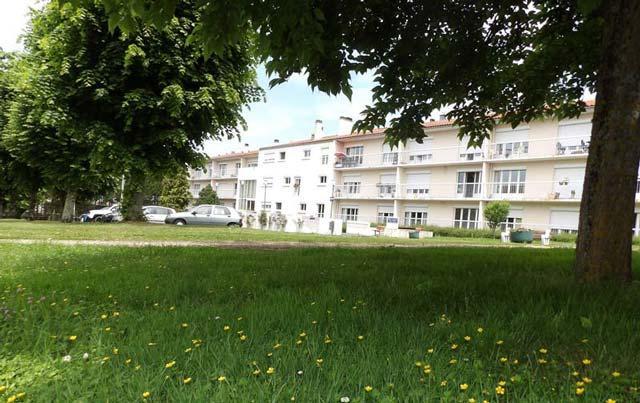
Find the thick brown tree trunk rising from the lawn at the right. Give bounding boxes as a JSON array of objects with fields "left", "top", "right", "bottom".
[{"left": 576, "top": 0, "right": 640, "bottom": 282}]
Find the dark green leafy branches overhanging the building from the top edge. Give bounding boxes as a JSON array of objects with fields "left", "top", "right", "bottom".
[{"left": 59, "top": 0, "right": 603, "bottom": 143}]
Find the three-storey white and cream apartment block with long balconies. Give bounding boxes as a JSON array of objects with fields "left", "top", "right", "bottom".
[{"left": 193, "top": 104, "right": 640, "bottom": 235}]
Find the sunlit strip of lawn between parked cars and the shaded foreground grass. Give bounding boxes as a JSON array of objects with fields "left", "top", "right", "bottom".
[{"left": 0, "top": 220, "right": 560, "bottom": 246}]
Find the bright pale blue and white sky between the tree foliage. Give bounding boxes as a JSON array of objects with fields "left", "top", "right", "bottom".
[{"left": 0, "top": 0, "right": 380, "bottom": 155}]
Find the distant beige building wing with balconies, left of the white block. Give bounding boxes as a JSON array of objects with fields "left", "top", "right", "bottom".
[{"left": 189, "top": 151, "right": 258, "bottom": 207}]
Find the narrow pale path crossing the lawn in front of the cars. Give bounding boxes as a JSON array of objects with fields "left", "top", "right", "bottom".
[{"left": 0, "top": 239, "right": 549, "bottom": 250}]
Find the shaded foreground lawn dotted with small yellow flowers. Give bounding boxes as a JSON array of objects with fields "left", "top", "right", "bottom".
[{"left": 0, "top": 245, "right": 640, "bottom": 402}]
